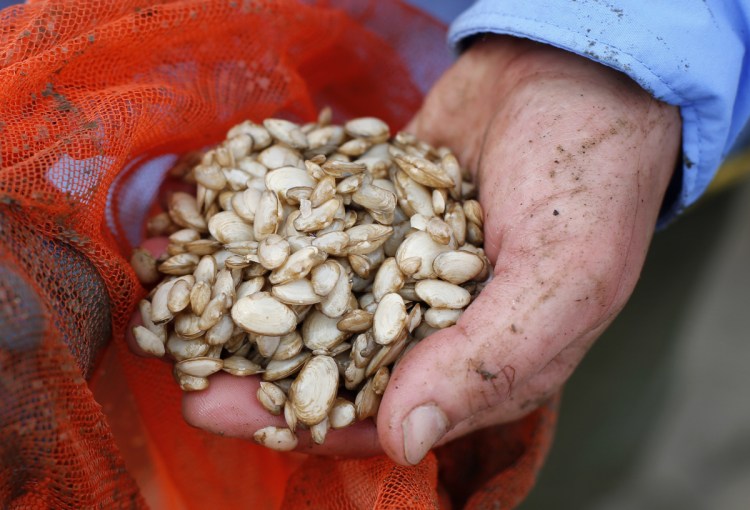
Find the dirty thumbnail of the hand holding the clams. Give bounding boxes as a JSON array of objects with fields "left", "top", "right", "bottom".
[{"left": 401, "top": 404, "right": 448, "bottom": 465}]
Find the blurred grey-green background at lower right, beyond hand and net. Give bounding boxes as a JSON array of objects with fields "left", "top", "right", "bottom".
[{"left": 521, "top": 177, "right": 750, "bottom": 510}]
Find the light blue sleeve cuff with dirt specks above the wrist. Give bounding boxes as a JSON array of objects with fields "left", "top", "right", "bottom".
[{"left": 449, "top": 0, "right": 750, "bottom": 223}]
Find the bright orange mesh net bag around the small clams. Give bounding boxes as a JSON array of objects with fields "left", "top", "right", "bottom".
[{"left": 0, "top": 0, "right": 555, "bottom": 509}]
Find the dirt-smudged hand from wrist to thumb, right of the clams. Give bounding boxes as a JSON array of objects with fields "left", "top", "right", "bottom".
[{"left": 377, "top": 37, "right": 680, "bottom": 464}]
